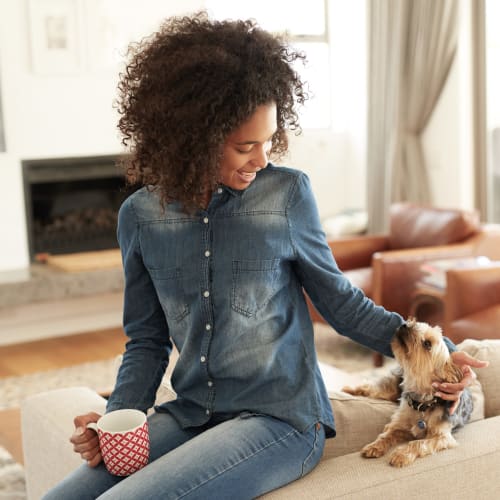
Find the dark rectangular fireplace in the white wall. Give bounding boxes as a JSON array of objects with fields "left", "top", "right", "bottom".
[{"left": 22, "top": 155, "right": 134, "bottom": 260}]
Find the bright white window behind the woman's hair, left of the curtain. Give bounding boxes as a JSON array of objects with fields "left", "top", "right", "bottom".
[{"left": 206, "top": 0, "right": 367, "bottom": 134}]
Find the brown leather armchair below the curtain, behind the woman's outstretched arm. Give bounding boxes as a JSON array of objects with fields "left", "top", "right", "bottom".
[{"left": 309, "top": 203, "right": 500, "bottom": 364}]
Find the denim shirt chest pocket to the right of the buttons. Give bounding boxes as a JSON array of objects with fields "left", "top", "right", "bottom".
[{"left": 231, "top": 259, "right": 284, "bottom": 316}]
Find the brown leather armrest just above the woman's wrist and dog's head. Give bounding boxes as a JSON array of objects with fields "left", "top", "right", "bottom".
[{"left": 372, "top": 243, "right": 474, "bottom": 317}]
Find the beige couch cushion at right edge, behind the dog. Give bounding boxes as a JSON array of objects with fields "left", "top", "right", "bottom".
[{"left": 457, "top": 339, "right": 500, "bottom": 418}]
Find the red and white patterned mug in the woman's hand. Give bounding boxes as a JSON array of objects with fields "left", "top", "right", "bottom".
[{"left": 87, "top": 410, "right": 149, "bottom": 476}]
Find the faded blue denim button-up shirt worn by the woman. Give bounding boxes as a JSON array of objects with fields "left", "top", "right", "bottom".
[{"left": 107, "top": 164, "right": 403, "bottom": 436}]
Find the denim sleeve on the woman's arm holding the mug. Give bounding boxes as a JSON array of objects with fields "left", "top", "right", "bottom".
[{"left": 106, "top": 198, "right": 172, "bottom": 411}]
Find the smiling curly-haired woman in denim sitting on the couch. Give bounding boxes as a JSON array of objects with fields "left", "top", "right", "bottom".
[{"left": 46, "top": 14, "right": 484, "bottom": 500}]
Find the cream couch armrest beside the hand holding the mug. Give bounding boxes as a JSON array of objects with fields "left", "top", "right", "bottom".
[{"left": 21, "top": 387, "right": 106, "bottom": 499}]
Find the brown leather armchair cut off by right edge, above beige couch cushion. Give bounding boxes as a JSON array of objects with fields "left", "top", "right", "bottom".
[{"left": 444, "top": 265, "right": 500, "bottom": 344}]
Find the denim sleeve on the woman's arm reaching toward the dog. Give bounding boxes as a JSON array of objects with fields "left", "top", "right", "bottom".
[{"left": 287, "top": 173, "right": 404, "bottom": 356}]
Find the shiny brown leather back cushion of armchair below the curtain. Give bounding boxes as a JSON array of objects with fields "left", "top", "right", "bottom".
[{"left": 389, "top": 203, "right": 480, "bottom": 249}]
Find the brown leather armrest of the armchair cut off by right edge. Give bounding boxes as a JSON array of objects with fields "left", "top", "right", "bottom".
[{"left": 445, "top": 265, "right": 500, "bottom": 323}]
